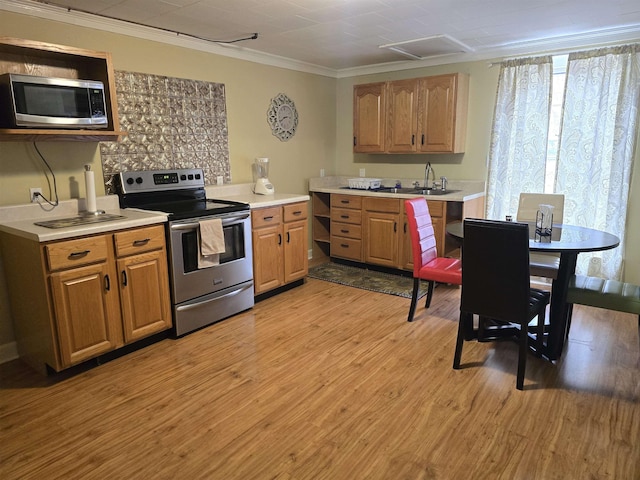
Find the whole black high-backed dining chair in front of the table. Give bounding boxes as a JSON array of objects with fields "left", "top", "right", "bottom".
[{"left": 453, "top": 219, "right": 550, "bottom": 390}]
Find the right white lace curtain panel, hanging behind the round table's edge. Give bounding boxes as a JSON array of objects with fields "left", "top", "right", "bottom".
[{"left": 555, "top": 44, "right": 640, "bottom": 278}]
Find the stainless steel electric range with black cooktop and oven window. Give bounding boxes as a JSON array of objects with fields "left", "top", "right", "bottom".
[{"left": 114, "top": 169, "right": 254, "bottom": 336}]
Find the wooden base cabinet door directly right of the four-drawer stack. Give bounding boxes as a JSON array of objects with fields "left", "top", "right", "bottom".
[{"left": 364, "top": 212, "right": 400, "bottom": 267}]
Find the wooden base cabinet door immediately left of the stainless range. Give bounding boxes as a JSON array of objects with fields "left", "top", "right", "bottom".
[{"left": 118, "top": 250, "right": 172, "bottom": 343}]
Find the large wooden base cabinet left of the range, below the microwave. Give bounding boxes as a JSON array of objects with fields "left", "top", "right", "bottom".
[{"left": 2, "top": 225, "right": 172, "bottom": 373}]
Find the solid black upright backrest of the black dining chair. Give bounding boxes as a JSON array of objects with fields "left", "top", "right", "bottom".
[{"left": 460, "top": 219, "right": 530, "bottom": 321}]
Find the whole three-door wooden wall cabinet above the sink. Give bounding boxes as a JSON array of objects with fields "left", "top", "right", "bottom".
[{"left": 353, "top": 73, "right": 469, "bottom": 153}]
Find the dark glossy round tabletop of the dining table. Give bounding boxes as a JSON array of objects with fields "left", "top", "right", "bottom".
[{"left": 447, "top": 222, "right": 620, "bottom": 252}]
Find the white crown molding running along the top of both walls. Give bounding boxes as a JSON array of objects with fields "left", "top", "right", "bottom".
[{"left": 0, "top": 0, "right": 640, "bottom": 78}]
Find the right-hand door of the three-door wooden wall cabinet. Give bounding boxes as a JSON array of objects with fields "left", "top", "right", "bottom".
[{"left": 419, "top": 75, "right": 457, "bottom": 152}]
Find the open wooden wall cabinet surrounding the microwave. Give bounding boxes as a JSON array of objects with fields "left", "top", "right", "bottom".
[{"left": 0, "top": 37, "right": 126, "bottom": 142}]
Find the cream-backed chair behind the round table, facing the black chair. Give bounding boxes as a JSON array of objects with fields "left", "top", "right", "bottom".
[{"left": 516, "top": 193, "right": 564, "bottom": 280}]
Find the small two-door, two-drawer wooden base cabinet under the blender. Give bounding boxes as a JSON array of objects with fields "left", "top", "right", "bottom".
[{"left": 251, "top": 202, "right": 309, "bottom": 295}]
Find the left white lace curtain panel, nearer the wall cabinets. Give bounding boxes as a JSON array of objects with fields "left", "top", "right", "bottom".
[{"left": 486, "top": 56, "right": 553, "bottom": 219}]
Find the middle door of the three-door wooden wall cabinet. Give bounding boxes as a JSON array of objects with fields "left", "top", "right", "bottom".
[{"left": 387, "top": 79, "right": 419, "bottom": 153}]
